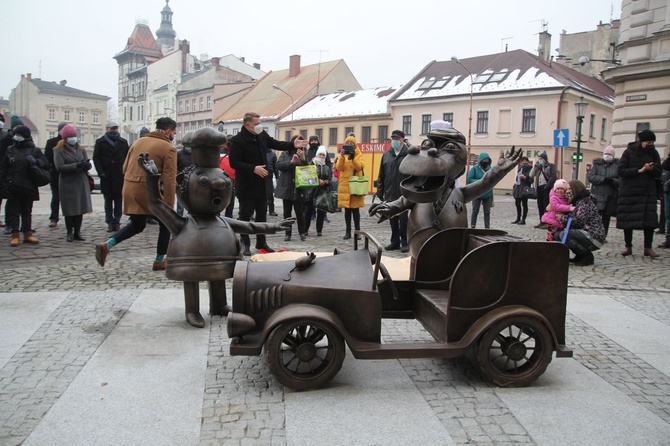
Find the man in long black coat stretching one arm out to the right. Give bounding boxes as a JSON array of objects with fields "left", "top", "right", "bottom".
[{"left": 229, "top": 112, "right": 307, "bottom": 256}]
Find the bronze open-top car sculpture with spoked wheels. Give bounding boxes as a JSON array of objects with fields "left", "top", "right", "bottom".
[{"left": 227, "top": 228, "right": 572, "bottom": 390}]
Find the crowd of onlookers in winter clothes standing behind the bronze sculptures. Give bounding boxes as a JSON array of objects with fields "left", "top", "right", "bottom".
[{"left": 0, "top": 113, "right": 670, "bottom": 270}]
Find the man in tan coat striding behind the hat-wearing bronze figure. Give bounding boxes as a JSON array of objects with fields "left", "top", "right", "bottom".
[{"left": 95, "top": 118, "right": 177, "bottom": 271}]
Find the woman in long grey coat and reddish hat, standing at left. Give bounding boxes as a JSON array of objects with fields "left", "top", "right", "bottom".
[{"left": 54, "top": 124, "right": 93, "bottom": 242}]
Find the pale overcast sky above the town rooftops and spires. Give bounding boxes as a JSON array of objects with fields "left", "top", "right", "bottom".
[{"left": 0, "top": 0, "right": 621, "bottom": 105}]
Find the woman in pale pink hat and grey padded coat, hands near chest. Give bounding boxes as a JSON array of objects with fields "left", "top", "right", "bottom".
[{"left": 586, "top": 146, "right": 619, "bottom": 235}]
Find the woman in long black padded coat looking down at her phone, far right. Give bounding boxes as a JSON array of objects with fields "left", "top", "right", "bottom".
[{"left": 616, "top": 130, "right": 662, "bottom": 259}]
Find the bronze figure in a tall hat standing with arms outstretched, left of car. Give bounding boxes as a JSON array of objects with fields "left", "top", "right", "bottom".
[{"left": 138, "top": 127, "right": 294, "bottom": 328}]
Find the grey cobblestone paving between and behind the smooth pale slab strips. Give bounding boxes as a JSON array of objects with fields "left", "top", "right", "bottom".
[{"left": 0, "top": 190, "right": 670, "bottom": 446}]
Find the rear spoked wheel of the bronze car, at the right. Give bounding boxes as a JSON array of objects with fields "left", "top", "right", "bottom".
[{"left": 475, "top": 316, "right": 552, "bottom": 387}]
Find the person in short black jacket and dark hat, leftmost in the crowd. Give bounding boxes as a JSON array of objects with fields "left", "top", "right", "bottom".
[{"left": 0, "top": 125, "right": 50, "bottom": 247}]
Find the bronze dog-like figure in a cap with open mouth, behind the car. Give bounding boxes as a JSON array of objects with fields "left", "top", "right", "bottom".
[{"left": 369, "top": 123, "right": 522, "bottom": 277}]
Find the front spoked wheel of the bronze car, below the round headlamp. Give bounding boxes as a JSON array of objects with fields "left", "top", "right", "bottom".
[{"left": 265, "top": 321, "right": 345, "bottom": 390}]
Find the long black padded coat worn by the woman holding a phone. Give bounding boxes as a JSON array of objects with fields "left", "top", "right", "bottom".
[{"left": 616, "top": 142, "right": 661, "bottom": 229}]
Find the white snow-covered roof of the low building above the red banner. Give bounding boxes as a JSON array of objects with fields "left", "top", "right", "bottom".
[{"left": 280, "top": 85, "right": 402, "bottom": 122}]
